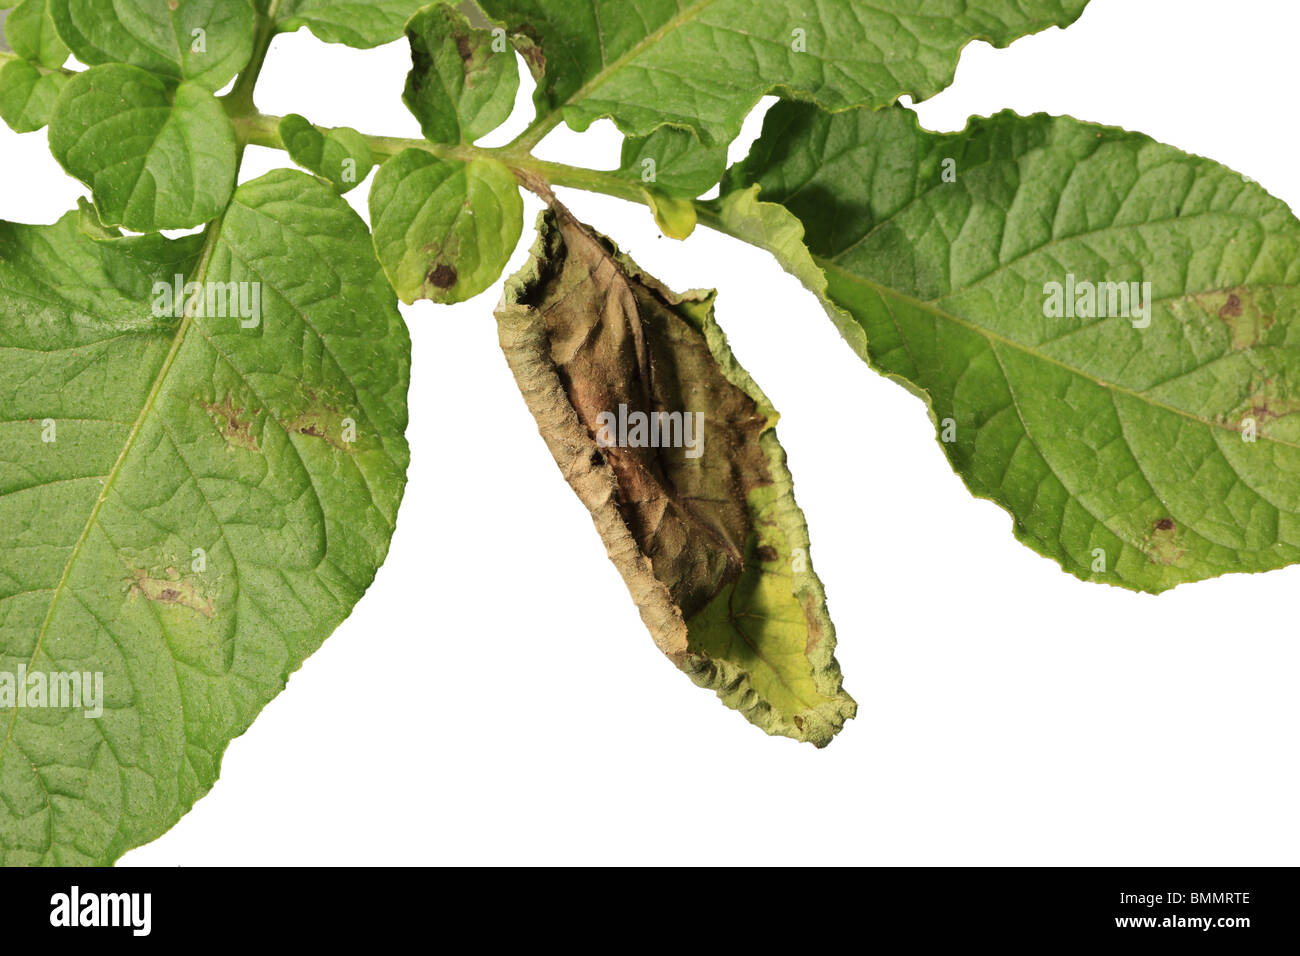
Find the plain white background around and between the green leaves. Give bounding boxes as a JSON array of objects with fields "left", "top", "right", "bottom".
[{"left": 0, "top": 0, "right": 1300, "bottom": 866}]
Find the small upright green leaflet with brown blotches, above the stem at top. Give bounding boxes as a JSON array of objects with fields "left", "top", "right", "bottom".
[{"left": 402, "top": 4, "right": 519, "bottom": 143}]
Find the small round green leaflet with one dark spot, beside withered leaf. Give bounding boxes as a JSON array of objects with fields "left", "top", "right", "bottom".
[{"left": 371, "top": 150, "right": 524, "bottom": 303}]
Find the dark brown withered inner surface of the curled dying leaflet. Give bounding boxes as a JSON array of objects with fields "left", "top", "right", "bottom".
[{"left": 506, "top": 204, "right": 772, "bottom": 620}]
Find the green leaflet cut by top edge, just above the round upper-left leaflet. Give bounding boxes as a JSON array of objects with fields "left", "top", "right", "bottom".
[{"left": 48, "top": 0, "right": 255, "bottom": 91}]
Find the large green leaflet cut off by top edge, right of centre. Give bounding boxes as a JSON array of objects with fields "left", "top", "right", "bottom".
[{"left": 480, "top": 0, "right": 1087, "bottom": 146}]
